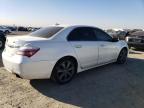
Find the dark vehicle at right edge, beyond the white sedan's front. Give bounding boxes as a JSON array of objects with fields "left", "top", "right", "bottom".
[{"left": 126, "top": 31, "right": 144, "bottom": 49}]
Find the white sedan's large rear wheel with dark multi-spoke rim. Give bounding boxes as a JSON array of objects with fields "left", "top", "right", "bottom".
[{"left": 51, "top": 58, "right": 77, "bottom": 84}]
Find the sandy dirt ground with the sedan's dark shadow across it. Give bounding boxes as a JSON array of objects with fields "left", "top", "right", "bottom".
[{"left": 0, "top": 52, "right": 144, "bottom": 108}]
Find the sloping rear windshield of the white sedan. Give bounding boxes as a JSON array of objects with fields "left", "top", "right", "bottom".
[{"left": 30, "top": 27, "right": 63, "bottom": 38}]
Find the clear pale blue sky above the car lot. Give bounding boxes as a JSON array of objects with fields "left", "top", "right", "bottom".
[{"left": 0, "top": 0, "right": 144, "bottom": 29}]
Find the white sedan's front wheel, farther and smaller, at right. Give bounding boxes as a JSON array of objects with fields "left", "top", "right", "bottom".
[{"left": 117, "top": 48, "right": 128, "bottom": 64}]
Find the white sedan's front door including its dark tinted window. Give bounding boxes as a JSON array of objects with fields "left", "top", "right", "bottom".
[{"left": 94, "top": 28, "right": 118, "bottom": 64}]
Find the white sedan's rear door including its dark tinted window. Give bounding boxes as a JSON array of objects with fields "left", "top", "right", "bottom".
[{"left": 68, "top": 27, "right": 98, "bottom": 68}]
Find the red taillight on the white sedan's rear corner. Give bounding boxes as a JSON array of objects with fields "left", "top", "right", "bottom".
[{"left": 16, "top": 48, "right": 40, "bottom": 57}]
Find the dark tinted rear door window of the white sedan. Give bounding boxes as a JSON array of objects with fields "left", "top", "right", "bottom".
[{"left": 67, "top": 27, "right": 96, "bottom": 41}]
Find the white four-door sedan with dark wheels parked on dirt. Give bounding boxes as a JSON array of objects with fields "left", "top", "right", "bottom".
[{"left": 2, "top": 26, "right": 128, "bottom": 84}]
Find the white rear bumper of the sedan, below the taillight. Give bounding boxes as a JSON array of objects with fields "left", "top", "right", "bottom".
[{"left": 2, "top": 53, "right": 55, "bottom": 79}]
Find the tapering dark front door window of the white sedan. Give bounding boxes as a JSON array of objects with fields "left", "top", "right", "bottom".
[{"left": 94, "top": 29, "right": 112, "bottom": 42}]
